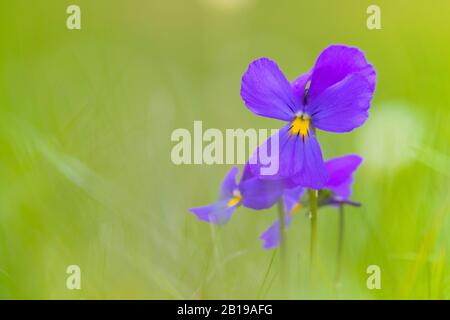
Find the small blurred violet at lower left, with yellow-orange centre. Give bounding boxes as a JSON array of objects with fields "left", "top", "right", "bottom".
[{"left": 189, "top": 165, "right": 284, "bottom": 224}]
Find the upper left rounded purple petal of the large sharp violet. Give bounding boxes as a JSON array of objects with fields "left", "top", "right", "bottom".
[{"left": 241, "top": 58, "right": 299, "bottom": 121}]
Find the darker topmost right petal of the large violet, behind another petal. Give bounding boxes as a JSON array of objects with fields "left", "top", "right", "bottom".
[{"left": 308, "top": 45, "right": 376, "bottom": 101}]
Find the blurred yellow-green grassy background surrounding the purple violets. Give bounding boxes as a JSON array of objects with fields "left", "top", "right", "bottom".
[{"left": 0, "top": 0, "right": 450, "bottom": 299}]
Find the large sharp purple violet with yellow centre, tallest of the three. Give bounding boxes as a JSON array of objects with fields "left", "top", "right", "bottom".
[{"left": 241, "top": 45, "right": 376, "bottom": 190}]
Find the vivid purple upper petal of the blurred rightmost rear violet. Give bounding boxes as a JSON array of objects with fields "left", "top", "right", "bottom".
[{"left": 325, "top": 155, "right": 363, "bottom": 200}]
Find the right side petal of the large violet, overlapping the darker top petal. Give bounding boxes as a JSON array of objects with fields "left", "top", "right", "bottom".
[{"left": 307, "top": 73, "right": 373, "bottom": 132}]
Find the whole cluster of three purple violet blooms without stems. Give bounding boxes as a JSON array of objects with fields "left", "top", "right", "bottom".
[{"left": 190, "top": 45, "right": 376, "bottom": 249}]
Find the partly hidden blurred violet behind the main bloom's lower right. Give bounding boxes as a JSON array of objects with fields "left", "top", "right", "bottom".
[{"left": 260, "top": 155, "right": 363, "bottom": 249}]
